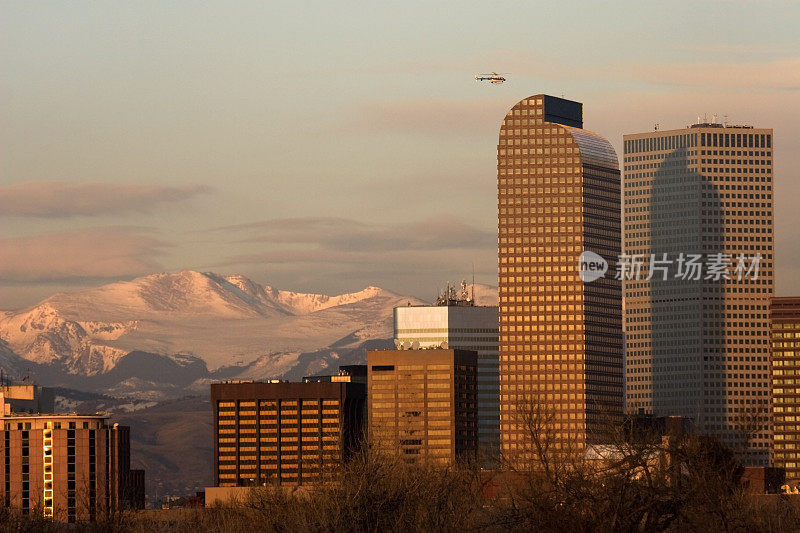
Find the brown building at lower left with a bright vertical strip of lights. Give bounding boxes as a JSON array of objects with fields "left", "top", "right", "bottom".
[{"left": 0, "top": 414, "right": 144, "bottom": 522}]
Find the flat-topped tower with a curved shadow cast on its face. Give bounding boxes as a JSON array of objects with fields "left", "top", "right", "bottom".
[{"left": 624, "top": 123, "right": 773, "bottom": 466}]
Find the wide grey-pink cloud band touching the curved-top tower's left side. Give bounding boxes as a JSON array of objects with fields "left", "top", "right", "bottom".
[{"left": 207, "top": 216, "right": 497, "bottom": 298}]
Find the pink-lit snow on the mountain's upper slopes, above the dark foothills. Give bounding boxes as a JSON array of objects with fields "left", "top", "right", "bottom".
[{"left": 0, "top": 270, "right": 422, "bottom": 375}]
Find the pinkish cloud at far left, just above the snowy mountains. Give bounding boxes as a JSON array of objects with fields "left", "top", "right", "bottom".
[{"left": 0, "top": 227, "right": 167, "bottom": 283}]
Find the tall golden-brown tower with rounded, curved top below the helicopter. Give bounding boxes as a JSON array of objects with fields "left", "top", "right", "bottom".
[{"left": 497, "top": 94, "right": 623, "bottom": 464}]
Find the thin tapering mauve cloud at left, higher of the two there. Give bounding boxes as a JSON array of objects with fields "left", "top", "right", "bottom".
[{"left": 0, "top": 181, "right": 211, "bottom": 218}]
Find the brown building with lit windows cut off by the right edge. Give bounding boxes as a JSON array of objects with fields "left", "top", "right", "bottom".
[{"left": 770, "top": 297, "right": 800, "bottom": 485}]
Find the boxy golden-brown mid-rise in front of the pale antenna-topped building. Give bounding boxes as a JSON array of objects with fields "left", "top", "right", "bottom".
[{"left": 367, "top": 349, "right": 478, "bottom": 463}]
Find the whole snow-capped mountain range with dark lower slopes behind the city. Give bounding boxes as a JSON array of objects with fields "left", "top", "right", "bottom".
[{"left": 0, "top": 270, "right": 496, "bottom": 397}]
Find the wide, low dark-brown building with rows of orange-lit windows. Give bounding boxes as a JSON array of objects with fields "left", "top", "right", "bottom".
[{"left": 211, "top": 381, "right": 365, "bottom": 487}]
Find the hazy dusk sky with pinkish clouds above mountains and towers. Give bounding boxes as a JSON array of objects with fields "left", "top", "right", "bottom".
[{"left": 0, "top": 0, "right": 800, "bottom": 309}]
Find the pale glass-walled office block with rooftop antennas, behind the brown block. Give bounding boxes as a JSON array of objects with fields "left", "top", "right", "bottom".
[{"left": 394, "top": 298, "right": 500, "bottom": 467}]
